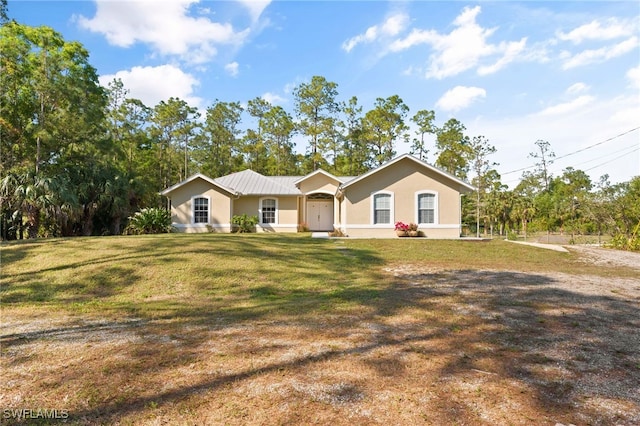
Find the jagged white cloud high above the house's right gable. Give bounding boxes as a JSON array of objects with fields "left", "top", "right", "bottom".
[{"left": 388, "top": 6, "right": 527, "bottom": 79}]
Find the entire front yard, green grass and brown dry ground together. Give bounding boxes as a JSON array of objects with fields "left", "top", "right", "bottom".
[{"left": 0, "top": 234, "right": 640, "bottom": 424}]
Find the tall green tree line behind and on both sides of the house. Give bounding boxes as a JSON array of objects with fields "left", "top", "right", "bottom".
[{"left": 0, "top": 20, "right": 640, "bottom": 239}]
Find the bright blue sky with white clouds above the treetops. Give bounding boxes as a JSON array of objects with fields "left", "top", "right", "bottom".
[{"left": 8, "top": 0, "right": 640, "bottom": 187}]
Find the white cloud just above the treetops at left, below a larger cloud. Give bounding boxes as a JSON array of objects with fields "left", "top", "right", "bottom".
[{"left": 100, "top": 65, "right": 202, "bottom": 108}]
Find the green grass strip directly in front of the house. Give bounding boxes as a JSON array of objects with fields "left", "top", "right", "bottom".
[{"left": 0, "top": 234, "right": 632, "bottom": 317}]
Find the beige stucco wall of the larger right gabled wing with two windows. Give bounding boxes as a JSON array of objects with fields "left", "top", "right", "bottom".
[{"left": 340, "top": 159, "right": 460, "bottom": 238}]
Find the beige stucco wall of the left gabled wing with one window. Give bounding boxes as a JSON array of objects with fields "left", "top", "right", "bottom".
[{"left": 169, "top": 179, "right": 231, "bottom": 232}]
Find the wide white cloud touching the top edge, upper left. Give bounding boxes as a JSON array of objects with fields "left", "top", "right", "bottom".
[{"left": 77, "top": 0, "right": 248, "bottom": 63}]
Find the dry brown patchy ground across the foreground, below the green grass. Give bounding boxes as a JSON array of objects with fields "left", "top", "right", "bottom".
[{"left": 0, "top": 248, "right": 640, "bottom": 425}]
